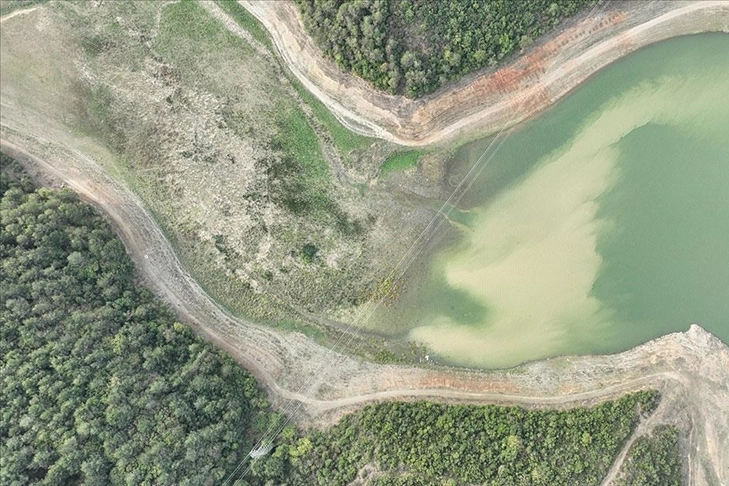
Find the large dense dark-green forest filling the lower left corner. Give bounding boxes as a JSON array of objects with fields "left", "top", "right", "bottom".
[{"left": 0, "top": 157, "right": 269, "bottom": 485}]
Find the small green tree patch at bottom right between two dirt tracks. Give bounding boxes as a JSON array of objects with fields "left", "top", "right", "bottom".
[{"left": 619, "top": 425, "right": 684, "bottom": 486}]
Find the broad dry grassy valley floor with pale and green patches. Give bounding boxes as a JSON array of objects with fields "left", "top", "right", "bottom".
[{"left": 3, "top": 1, "right": 438, "bottom": 352}]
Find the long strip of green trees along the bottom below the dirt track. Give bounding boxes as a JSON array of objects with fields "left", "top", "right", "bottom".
[{"left": 249, "top": 391, "right": 658, "bottom": 486}]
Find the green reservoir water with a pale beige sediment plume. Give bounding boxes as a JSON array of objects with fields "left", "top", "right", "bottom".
[{"left": 372, "top": 34, "right": 729, "bottom": 368}]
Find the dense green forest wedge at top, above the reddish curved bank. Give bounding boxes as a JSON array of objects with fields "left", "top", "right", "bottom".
[{"left": 296, "top": 0, "right": 595, "bottom": 98}]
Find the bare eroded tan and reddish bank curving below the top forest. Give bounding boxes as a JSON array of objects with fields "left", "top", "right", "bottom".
[{"left": 239, "top": 0, "right": 729, "bottom": 146}]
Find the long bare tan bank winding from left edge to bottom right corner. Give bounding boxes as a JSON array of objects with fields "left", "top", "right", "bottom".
[{"left": 2, "top": 136, "right": 729, "bottom": 485}]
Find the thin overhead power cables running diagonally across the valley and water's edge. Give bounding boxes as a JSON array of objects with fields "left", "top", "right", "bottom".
[{"left": 216, "top": 0, "right": 611, "bottom": 486}]
